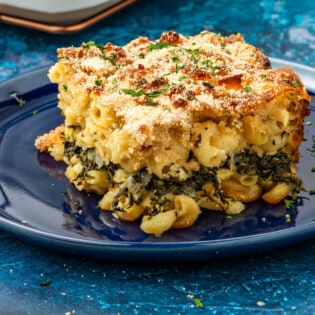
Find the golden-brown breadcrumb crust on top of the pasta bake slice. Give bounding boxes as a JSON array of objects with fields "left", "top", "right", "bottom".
[{"left": 51, "top": 31, "right": 309, "bottom": 119}]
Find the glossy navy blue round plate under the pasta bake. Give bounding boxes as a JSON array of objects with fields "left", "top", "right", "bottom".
[{"left": 0, "top": 59, "right": 315, "bottom": 261}]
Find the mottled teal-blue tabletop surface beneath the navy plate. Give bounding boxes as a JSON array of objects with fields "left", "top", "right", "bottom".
[{"left": 0, "top": 0, "right": 315, "bottom": 315}]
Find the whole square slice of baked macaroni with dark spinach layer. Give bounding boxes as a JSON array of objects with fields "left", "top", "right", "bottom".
[{"left": 36, "top": 31, "right": 310, "bottom": 234}]
